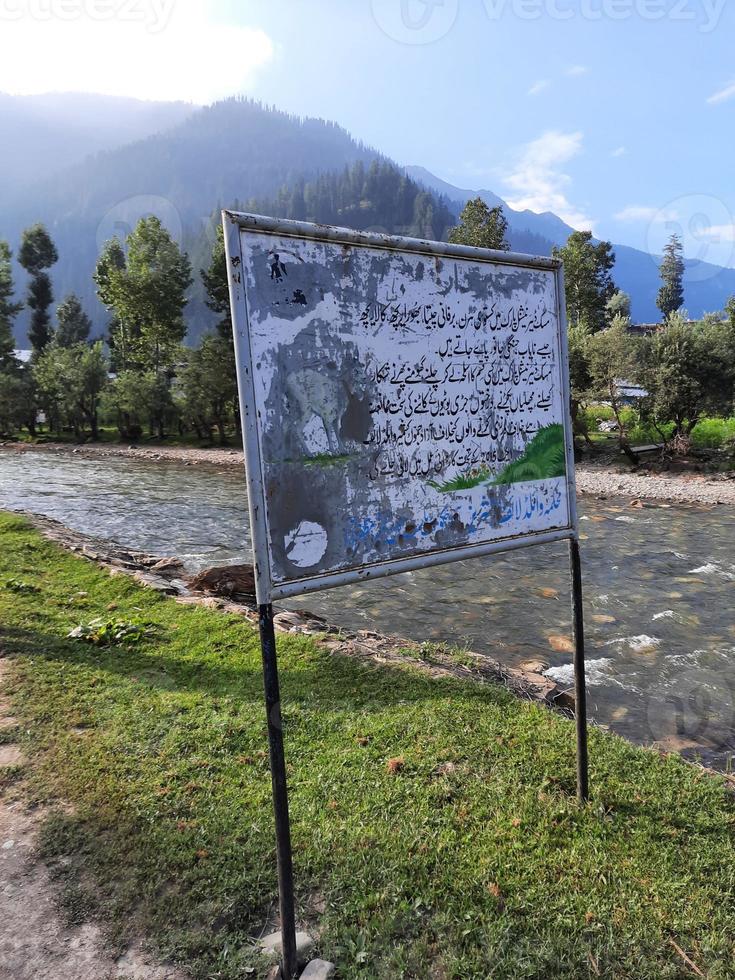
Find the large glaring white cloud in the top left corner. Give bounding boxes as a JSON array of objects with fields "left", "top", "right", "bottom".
[{"left": 0, "top": 0, "right": 274, "bottom": 103}]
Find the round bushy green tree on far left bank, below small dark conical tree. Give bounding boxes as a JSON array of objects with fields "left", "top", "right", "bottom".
[{"left": 33, "top": 341, "right": 108, "bottom": 440}]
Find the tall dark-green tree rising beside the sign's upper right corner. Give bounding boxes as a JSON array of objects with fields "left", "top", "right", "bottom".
[{"left": 552, "top": 231, "right": 616, "bottom": 333}]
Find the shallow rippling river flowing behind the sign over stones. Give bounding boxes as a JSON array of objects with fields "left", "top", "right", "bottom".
[{"left": 0, "top": 452, "right": 735, "bottom": 767}]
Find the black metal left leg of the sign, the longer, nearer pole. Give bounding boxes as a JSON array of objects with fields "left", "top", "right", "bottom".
[{"left": 258, "top": 603, "right": 297, "bottom": 980}]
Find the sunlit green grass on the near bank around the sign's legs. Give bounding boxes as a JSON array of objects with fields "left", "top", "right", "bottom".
[{"left": 0, "top": 515, "right": 735, "bottom": 980}]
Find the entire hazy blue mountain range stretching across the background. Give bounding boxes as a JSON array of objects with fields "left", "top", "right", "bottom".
[{"left": 0, "top": 95, "right": 735, "bottom": 347}]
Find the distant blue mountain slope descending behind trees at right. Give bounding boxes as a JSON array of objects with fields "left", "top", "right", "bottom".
[{"left": 405, "top": 167, "right": 735, "bottom": 323}]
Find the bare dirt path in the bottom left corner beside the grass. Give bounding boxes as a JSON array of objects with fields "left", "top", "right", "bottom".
[{"left": 0, "top": 655, "right": 184, "bottom": 980}]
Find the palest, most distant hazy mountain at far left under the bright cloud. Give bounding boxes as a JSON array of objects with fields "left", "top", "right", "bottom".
[{"left": 0, "top": 92, "right": 195, "bottom": 204}]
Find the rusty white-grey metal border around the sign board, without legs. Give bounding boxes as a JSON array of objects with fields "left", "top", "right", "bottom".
[{"left": 223, "top": 211, "right": 578, "bottom": 603}]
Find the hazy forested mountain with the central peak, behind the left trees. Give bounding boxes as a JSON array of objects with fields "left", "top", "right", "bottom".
[{"left": 0, "top": 98, "right": 380, "bottom": 345}]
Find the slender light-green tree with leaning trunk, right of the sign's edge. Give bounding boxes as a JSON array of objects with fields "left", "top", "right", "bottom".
[{"left": 589, "top": 316, "right": 638, "bottom": 464}]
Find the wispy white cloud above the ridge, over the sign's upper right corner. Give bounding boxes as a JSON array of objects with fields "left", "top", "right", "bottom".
[{"left": 505, "top": 131, "right": 593, "bottom": 231}]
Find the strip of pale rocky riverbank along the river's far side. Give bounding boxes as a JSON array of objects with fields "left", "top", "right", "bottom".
[{"left": 0, "top": 442, "right": 735, "bottom": 506}]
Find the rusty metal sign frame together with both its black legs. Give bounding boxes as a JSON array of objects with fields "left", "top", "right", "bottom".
[{"left": 222, "top": 211, "right": 589, "bottom": 980}]
